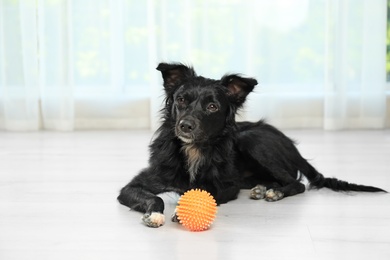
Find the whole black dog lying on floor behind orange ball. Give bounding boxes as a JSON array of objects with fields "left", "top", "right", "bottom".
[{"left": 118, "top": 63, "right": 384, "bottom": 227}]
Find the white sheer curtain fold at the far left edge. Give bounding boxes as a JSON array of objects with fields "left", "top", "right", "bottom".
[{"left": 0, "top": 1, "right": 40, "bottom": 131}]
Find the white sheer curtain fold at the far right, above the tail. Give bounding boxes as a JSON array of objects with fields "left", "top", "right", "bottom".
[{"left": 324, "top": 0, "right": 387, "bottom": 129}]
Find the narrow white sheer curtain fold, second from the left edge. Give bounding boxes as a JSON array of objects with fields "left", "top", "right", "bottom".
[{"left": 37, "top": 0, "right": 75, "bottom": 131}]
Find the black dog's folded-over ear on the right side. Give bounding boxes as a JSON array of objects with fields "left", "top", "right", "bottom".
[{"left": 221, "top": 74, "right": 257, "bottom": 106}]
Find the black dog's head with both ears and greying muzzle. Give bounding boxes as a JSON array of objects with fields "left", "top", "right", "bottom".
[{"left": 157, "top": 63, "right": 257, "bottom": 144}]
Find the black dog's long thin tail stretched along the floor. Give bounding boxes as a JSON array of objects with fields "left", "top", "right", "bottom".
[{"left": 300, "top": 161, "right": 387, "bottom": 193}]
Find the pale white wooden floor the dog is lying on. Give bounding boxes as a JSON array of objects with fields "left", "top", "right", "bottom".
[{"left": 0, "top": 130, "right": 390, "bottom": 260}]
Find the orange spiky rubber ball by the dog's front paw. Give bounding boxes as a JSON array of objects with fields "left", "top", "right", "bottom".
[{"left": 176, "top": 189, "right": 217, "bottom": 231}]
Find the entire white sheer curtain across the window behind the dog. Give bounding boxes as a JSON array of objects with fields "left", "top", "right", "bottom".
[{"left": 0, "top": 0, "right": 389, "bottom": 131}]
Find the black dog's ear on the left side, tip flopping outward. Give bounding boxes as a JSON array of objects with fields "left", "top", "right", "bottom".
[{"left": 156, "top": 63, "right": 196, "bottom": 91}]
